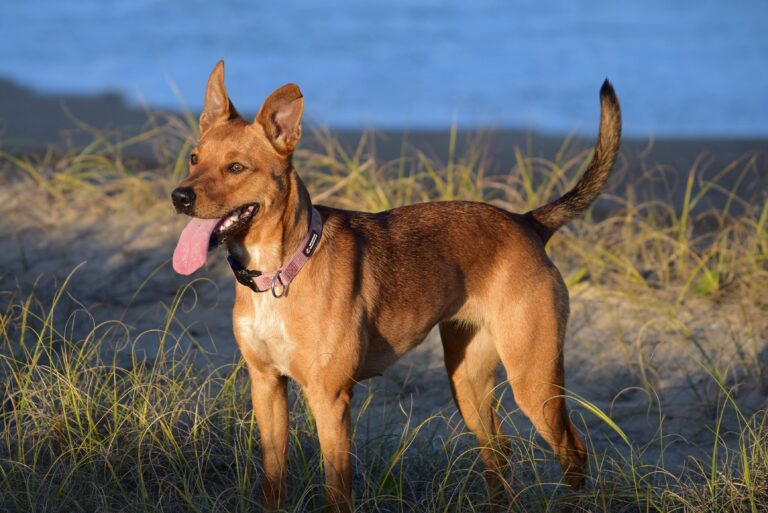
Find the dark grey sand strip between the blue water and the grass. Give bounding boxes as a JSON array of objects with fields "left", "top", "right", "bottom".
[{"left": 0, "top": 79, "right": 768, "bottom": 208}]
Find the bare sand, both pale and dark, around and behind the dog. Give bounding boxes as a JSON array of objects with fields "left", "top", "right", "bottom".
[{"left": 0, "top": 78, "right": 768, "bottom": 478}]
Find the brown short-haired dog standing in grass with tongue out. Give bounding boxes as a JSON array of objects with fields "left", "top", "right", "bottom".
[{"left": 172, "top": 62, "right": 621, "bottom": 511}]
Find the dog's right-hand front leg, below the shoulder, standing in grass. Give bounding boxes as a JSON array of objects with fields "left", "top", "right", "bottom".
[{"left": 305, "top": 383, "right": 353, "bottom": 513}]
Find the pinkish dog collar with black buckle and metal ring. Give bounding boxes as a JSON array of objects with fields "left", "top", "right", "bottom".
[{"left": 227, "top": 207, "right": 323, "bottom": 297}]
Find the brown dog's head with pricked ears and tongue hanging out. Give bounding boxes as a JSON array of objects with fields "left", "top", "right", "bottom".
[{"left": 171, "top": 61, "right": 304, "bottom": 274}]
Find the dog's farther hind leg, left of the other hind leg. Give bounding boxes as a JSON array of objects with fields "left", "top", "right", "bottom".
[{"left": 440, "top": 321, "right": 509, "bottom": 497}]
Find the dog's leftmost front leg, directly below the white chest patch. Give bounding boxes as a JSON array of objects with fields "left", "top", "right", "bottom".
[{"left": 248, "top": 364, "right": 288, "bottom": 511}]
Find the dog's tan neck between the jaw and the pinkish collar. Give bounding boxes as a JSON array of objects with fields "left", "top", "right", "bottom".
[{"left": 227, "top": 167, "right": 312, "bottom": 272}]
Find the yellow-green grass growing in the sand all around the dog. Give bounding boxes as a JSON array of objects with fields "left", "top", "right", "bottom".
[{"left": 0, "top": 114, "right": 768, "bottom": 512}]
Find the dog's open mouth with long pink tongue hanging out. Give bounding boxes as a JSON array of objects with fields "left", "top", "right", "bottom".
[{"left": 173, "top": 204, "right": 259, "bottom": 275}]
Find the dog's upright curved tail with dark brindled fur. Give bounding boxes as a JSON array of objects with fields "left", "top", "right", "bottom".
[{"left": 528, "top": 80, "right": 621, "bottom": 242}]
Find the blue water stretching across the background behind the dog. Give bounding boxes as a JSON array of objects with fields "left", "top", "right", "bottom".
[{"left": 0, "top": 0, "right": 768, "bottom": 136}]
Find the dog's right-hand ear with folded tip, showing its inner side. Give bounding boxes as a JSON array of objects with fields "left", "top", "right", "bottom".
[{"left": 256, "top": 84, "right": 304, "bottom": 155}]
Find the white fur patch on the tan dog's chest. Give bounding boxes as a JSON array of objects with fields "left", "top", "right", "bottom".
[{"left": 235, "top": 292, "right": 297, "bottom": 377}]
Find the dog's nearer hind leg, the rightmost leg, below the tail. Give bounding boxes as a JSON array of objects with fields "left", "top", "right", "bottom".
[{"left": 490, "top": 276, "right": 586, "bottom": 488}]
